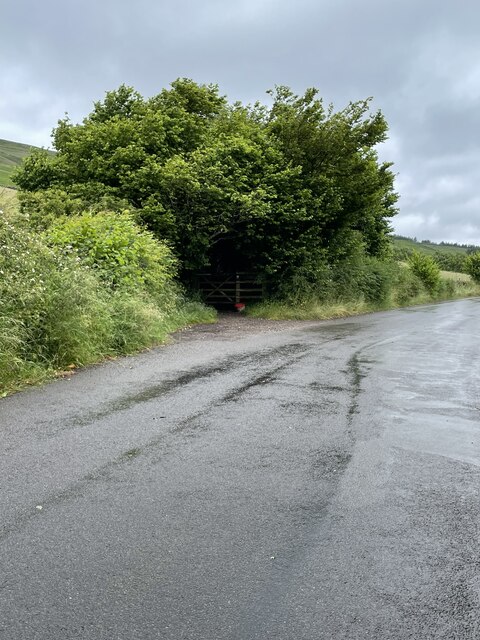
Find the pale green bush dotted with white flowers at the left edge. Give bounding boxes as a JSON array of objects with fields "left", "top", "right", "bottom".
[{"left": 0, "top": 218, "right": 112, "bottom": 384}]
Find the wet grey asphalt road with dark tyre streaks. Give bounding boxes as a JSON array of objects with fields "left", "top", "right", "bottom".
[{"left": 0, "top": 299, "right": 480, "bottom": 640}]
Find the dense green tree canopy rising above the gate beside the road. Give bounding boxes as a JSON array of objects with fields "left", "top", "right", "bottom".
[{"left": 16, "top": 79, "right": 397, "bottom": 284}]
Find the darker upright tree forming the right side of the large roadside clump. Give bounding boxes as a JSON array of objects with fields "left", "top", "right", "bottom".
[{"left": 268, "top": 87, "right": 397, "bottom": 256}]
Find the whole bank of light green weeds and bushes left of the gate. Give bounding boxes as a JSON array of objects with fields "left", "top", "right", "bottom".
[{"left": 0, "top": 207, "right": 215, "bottom": 395}]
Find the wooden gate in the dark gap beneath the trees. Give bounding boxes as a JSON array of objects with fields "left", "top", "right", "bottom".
[{"left": 197, "top": 273, "right": 264, "bottom": 308}]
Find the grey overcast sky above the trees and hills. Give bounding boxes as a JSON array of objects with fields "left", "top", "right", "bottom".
[{"left": 0, "top": 0, "right": 480, "bottom": 245}]
